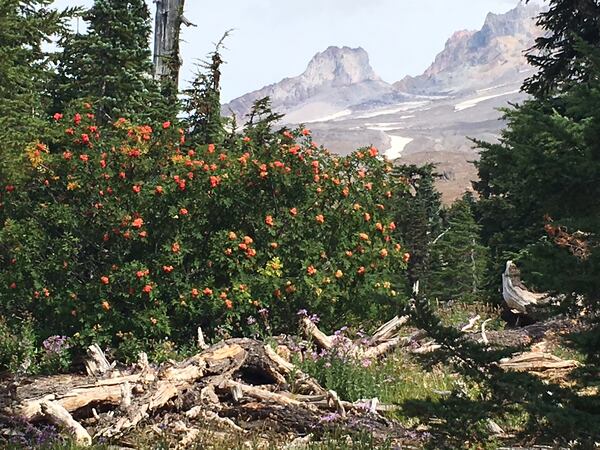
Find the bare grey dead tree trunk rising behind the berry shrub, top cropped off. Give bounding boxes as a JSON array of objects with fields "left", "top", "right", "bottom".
[{"left": 154, "top": 0, "right": 193, "bottom": 87}]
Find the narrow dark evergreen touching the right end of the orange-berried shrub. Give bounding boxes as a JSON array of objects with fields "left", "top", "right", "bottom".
[{"left": 395, "top": 164, "right": 442, "bottom": 292}]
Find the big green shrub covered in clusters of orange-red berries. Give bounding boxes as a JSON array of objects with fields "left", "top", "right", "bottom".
[{"left": 0, "top": 105, "right": 409, "bottom": 358}]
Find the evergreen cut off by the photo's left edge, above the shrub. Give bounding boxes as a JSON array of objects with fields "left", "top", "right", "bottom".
[{"left": 0, "top": 0, "right": 75, "bottom": 183}]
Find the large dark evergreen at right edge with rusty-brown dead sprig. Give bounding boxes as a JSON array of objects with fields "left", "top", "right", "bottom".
[{"left": 475, "top": 0, "right": 600, "bottom": 360}]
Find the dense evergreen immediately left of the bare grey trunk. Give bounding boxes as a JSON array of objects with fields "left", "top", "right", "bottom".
[{"left": 55, "top": 0, "right": 177, "bottom": 121}]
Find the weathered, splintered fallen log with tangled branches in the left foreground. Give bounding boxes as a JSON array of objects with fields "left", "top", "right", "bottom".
[{"left": 0, "top": 338, "right": 406, "bottom": 448}]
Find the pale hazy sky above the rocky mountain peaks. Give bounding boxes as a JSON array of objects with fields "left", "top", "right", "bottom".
[{"left": 55, "top": 0, "right": 518, "bottom": 101}]
